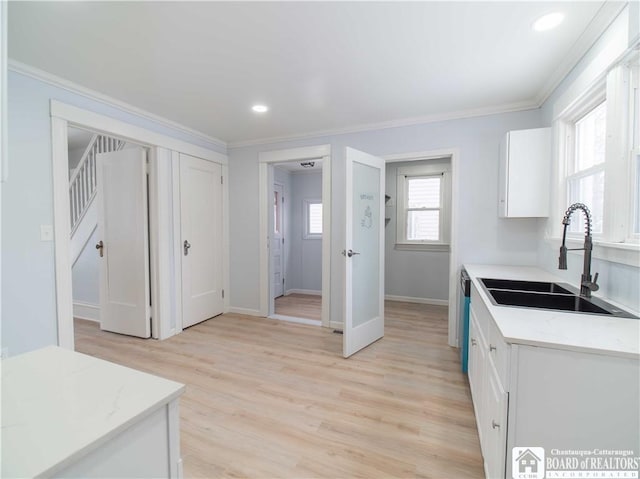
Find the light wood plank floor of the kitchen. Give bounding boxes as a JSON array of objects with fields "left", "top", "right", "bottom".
[{"left": 75, "top": 302, "right": 483, "bottom": 479}]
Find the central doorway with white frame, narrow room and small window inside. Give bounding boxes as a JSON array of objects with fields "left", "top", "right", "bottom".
[{"left": 259, "top": 145, "right": 332, "bottom": 327}]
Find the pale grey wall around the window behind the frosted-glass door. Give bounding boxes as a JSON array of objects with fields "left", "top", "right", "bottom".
[{"left": 384, "top": 160, "right": 449, "bottom": 301}]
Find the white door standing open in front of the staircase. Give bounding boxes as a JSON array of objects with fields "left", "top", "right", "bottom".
[{"left": 96, "top": 148, "right": 151, "bottom": 338}]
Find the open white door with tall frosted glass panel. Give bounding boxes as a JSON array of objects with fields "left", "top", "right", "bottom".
[{"left": 342, "top": 148, "right": 385, "bottom": 358}]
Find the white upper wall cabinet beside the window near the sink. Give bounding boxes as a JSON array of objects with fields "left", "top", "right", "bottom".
[{"left": 498, "top": 128, "right": 551, "bottom": 218}]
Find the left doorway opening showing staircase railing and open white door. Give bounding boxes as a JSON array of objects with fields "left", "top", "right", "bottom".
[{"left": 67, "top": 125, "right": 152, "bottom": 338}]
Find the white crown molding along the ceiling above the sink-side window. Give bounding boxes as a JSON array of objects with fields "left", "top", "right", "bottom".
[{"left": 536, "top": 0, "right": 628, "bottom": 106}]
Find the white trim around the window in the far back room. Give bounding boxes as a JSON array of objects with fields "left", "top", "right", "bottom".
[{"left": 395, "top": 163, "right": 451, "bottom": 252}]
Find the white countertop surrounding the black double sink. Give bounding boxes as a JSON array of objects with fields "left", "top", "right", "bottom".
[{"left": 464, "top": 264, "right": 640, "bottom": 359}]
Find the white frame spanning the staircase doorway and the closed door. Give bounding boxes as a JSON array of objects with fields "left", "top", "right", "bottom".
[{"left": 50, "top": 100, "right": 229, "bottom": 350}]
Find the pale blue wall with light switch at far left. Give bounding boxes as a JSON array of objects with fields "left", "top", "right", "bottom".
[{"left": 2, "top": 71, "right": 225, "bottom": 355}]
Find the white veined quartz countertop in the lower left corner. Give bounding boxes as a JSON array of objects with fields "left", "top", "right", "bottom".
[{"left": 0, "top": 346, "right": 185, "bottom": 478}]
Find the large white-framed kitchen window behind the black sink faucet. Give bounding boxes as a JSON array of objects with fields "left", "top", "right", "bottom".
[{"left": 559, "top": 54, "right": 640, "bottom": 246}]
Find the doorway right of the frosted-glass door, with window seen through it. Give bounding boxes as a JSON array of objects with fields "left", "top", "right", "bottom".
[{"left": 384, "top": 148, "right": 461, "bottom": 347}]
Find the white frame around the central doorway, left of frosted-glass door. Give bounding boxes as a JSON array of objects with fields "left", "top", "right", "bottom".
[{"left": 258, "top": 144, "right": 331, "bottom": 328}]
